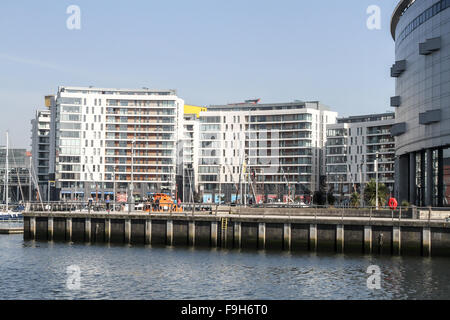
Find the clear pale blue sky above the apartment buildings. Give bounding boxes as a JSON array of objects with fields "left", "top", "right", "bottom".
[{"left": 0, "top": 0, "right": 398, "bottom": 149}]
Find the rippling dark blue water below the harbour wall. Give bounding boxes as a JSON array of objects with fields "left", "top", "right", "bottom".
[{"left": 0, "top": 235, "right": 450, "bottom": 299}]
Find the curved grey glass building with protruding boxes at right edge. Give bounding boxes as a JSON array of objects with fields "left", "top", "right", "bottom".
[{"left": 391, "top": 0, "right": 450, "bottom": 206}]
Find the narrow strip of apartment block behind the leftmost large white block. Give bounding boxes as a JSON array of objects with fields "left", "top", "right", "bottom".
[{"left": 31, "top": 104, "right": 52, "bottom": 200}]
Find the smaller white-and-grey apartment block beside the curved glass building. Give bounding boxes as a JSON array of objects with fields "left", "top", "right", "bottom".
[{"left": 326, "top": 113, "right": 395, "bottom": 203}]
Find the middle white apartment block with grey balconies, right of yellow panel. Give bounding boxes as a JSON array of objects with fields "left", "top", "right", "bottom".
[{"left": 198, "top": 100, "right": 337, "bottom": 203}]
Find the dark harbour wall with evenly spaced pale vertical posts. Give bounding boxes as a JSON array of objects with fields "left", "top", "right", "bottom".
[{"left": 24, "top": 212, "right": 450, "bottom": 256}]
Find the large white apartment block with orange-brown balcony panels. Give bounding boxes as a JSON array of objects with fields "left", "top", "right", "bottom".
[{"left": 49, "top": 86, "right": 184, "bottom": 200}]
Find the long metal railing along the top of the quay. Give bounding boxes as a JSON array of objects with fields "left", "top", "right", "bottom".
[{"left": 25, "top": 201, "right": 450, "bottom": 222}]
